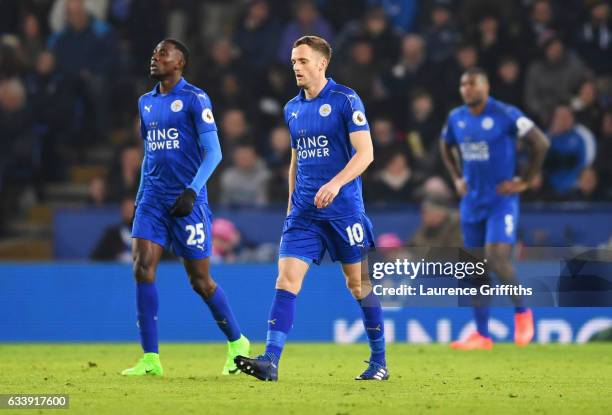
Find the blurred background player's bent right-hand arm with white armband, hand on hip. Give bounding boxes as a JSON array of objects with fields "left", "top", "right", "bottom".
[{"left": 497, "top": 110, "right": 550, "bottom": 195}]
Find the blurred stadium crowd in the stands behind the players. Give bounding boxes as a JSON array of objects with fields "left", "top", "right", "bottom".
[{"left": 0, "top": 0, "right": 612, "bottom": 236}]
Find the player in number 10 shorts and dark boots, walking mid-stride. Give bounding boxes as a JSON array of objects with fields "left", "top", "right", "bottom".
[{"left": 236, "top": 36, "right": 389, "bottom": 381}]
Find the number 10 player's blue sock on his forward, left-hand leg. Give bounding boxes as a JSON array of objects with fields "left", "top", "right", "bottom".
[{"left": 265, "top": 289, "right": 297, "bottom": 362}]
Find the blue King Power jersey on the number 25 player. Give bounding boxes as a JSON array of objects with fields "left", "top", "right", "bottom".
[{"left": 138, "top": 79, "right": 217, "bottom": 203}]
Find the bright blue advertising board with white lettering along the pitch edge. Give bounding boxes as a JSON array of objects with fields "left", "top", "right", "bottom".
[{"left": 0, "top": 263, "right": 612, "bottom": 343}]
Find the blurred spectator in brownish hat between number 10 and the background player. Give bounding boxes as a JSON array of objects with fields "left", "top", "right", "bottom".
[{"left": 407, "top": 193, "right": 463, "bottom": 248}]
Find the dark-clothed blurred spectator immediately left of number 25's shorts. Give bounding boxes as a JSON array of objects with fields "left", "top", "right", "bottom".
[{"left": 91, "top": 196, "right": 134, "bottom": 263}]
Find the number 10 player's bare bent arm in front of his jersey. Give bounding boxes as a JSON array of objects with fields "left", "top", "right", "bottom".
[{"left": 314, "top": 130, "right": 374, "bottom": 209}]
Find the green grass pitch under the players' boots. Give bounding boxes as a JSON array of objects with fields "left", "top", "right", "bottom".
[{"left": 0, "top": 343, "right": 612, "bottom": 415}]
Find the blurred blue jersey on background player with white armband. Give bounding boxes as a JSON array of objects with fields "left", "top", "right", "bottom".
[{"left": 442, "top": 97, "right": 534, "bottom": 220}]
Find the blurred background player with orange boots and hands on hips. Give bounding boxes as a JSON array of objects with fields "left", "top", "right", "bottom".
[{"left": 440, "top": 68, "right": 549, "bottom": 350}]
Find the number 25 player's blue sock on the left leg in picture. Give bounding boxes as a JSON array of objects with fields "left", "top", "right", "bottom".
[{"left": 136, "top": 282, "right": 159, "bottom": 353}]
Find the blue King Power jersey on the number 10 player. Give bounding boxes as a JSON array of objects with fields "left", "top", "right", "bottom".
[{"left": 284, "top": 78, "right": 370, "bottom": 219}]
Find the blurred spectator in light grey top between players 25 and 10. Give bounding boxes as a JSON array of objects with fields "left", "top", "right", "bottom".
[{"left": 221, "top": 143, "right": 270, "bottom": 206}]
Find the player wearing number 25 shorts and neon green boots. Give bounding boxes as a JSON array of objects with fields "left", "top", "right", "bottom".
[{"left": 122, "top": 39, "right": 250, "bottom": 376}]
